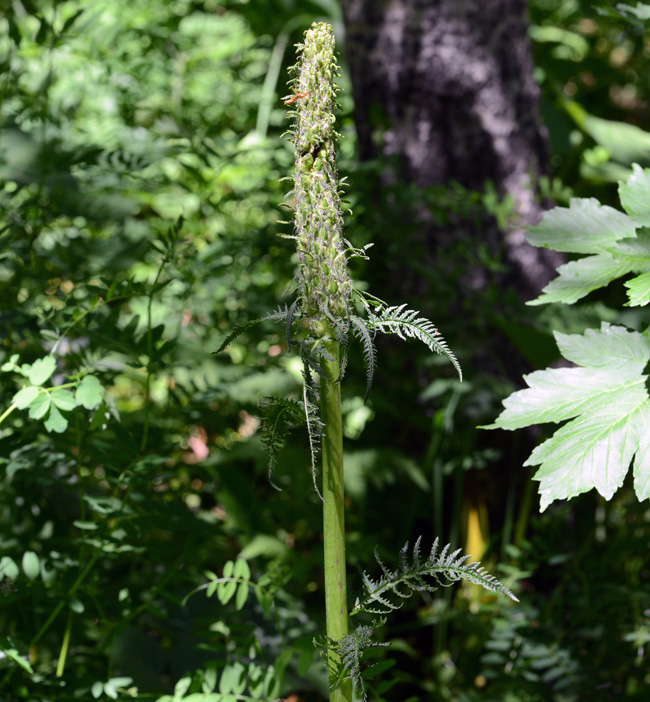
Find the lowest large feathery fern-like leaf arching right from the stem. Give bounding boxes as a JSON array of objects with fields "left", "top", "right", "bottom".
[{"left": 350, "top": 538, "right": 518, "bottom": 614}]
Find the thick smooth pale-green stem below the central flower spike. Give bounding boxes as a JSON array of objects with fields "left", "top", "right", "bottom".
[{"left": 321, "top": 339, "right": 352, "bottom": 702}]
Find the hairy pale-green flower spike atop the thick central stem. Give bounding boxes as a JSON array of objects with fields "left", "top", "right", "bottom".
[{"left": 285, "top": 22, "right": 352, "bottom": 336}]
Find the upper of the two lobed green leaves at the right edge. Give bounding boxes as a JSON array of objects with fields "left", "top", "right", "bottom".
[{"left": 527, "top": 164, "right": 650, "bottom": 306}]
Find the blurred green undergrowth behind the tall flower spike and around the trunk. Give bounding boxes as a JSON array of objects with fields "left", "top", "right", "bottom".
[{"left": 0, "top": 0, "right": 650, "bottom": 702}]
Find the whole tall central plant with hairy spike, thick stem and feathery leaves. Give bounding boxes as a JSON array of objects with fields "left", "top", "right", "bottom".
[{"left": 219, "top": 23, "right": 516, "bottom": 702}]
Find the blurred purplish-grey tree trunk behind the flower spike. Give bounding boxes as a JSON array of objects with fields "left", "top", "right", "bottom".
[{"left": 342, "top": 0, "right": 560, "bottom": 299}]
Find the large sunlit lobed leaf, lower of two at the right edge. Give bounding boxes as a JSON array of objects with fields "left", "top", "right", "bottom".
[{"left": 484, "top": 322, "right": 650, "bottom": 510}]
